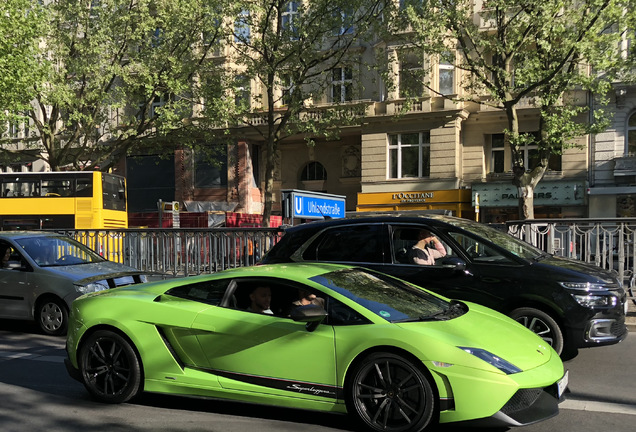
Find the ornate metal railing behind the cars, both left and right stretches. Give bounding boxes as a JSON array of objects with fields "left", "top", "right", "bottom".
[{"left": 58, "top": 218, "right": 636, "bottom": 282}]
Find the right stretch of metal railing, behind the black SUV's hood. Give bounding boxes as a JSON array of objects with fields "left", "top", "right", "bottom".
[{"left": 506, "top": 218, "right": 636, "bottom": 284}]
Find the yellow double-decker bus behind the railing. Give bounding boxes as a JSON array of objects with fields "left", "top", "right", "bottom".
[{"left": 0, "top": 171, "right": 128, "bottom": 230}]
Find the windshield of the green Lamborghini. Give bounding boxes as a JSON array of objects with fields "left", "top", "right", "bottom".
[{"left": 311, "top": 268, "right": 450, "bottom": 322}]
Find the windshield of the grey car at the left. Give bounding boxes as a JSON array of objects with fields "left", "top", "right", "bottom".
[{"left": 16, "top": 236, "right": 104, "bottom": 267}]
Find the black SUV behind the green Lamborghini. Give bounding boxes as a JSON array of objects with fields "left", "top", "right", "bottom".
[{"left": 262, "top": 216, "right": 627, "bottom": 354}]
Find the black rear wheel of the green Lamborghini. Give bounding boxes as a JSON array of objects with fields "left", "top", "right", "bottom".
[{"left": 79, "top": 330, "right": 141, "bottom": 404}]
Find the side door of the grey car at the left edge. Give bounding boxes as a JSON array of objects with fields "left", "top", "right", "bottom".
[{"left": 0, "top": 242, "right": 33, "bottom": 319}]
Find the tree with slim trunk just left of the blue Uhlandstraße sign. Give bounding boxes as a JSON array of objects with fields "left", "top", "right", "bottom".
[{"left": 202, "top": 0, "right": 384, "bottom": 228}]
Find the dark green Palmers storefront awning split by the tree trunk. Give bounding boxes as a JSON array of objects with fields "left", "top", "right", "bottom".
[{"left": 472, "top": 180, "right": 587, "bottom": 223}]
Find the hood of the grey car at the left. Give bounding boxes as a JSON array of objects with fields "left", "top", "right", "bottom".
[{"left": 44, "top": 261, "right": 145, "bottom": 286}]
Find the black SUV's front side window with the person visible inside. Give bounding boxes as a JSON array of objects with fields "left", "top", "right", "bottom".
[{"left": 391, "top": 226, "right": 457, "bottom": 265}]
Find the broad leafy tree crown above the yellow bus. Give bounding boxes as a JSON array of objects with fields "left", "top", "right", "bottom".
[{"left": 3, "top": 0, "right": 227, "bottom": 170}]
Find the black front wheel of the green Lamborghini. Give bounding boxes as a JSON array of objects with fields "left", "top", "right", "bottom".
[{"left": 346, "top": 352, "right": 435, "bottom": 432}]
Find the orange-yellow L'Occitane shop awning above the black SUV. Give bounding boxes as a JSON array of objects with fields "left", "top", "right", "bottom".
[{"left": 356, "top": 189, "right": 475, "bottom": 219}]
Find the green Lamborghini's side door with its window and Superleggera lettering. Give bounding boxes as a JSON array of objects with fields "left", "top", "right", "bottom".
[{"left": 192, "top": 280, "right": 337, "bottom": 400}]
